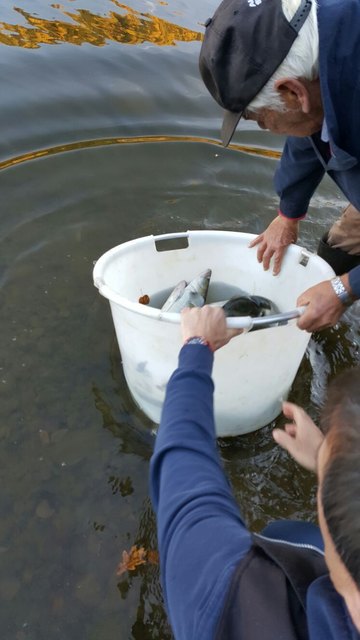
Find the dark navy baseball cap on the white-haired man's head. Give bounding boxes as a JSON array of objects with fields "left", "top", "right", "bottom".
[{"left": 199, "top": 0, "right": 311, "bottom": 147}]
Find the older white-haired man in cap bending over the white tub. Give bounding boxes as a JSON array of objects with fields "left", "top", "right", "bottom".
[{"left": 200, "top": 0, "right": 360, "bottom": 331}]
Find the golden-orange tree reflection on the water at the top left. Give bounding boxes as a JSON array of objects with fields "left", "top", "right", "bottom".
[{"left": 0, "top": 3, "right": 202, "bottom": 49}]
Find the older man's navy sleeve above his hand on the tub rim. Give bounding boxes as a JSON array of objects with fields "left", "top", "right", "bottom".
[{"left": 274, "top": 136, "right": 325, "bottom": 220}]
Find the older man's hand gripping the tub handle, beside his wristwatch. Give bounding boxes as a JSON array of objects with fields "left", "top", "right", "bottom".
[{"left": 296, "top": 280, "right": 346, "bottom": 332}]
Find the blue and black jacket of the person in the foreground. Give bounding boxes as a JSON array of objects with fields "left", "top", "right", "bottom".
[{"left": 150, "top": 344, "right": 360, "bottom": 640}]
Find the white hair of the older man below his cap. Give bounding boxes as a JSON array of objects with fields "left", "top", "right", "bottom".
[{"left": 248, "top": 0, "right": 319, "bottom": 111}]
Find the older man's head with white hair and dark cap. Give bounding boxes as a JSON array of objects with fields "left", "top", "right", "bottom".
[{"left": 199, "top": 0, "right": 323, "bottom": 146}]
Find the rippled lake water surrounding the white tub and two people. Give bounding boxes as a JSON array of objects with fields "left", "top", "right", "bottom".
[{"left": 0, "top": 0, "right": 359, "bottom": 640}]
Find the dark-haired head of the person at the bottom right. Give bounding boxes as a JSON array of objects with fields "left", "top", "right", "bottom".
[{"left": 318, "top": 367, "right": 360, "bottom": 631}]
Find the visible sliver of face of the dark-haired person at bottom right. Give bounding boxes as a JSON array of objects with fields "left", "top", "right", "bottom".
[{"left": 317, "top": 438, "right": 360, "bottom": 631}]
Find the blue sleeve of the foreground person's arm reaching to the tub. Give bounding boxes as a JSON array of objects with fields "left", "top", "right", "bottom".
[{"left": 150, "top": 344, "right": 251, "bottom": 640}]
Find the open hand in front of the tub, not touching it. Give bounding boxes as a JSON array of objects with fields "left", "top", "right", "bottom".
[{"left": 273, "top": 402, "right": 324, "bottom": 472}]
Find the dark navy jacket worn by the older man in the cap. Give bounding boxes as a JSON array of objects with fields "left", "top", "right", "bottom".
[{"left": 275, "top": 0, "right": 360, "bottom": 297}]
